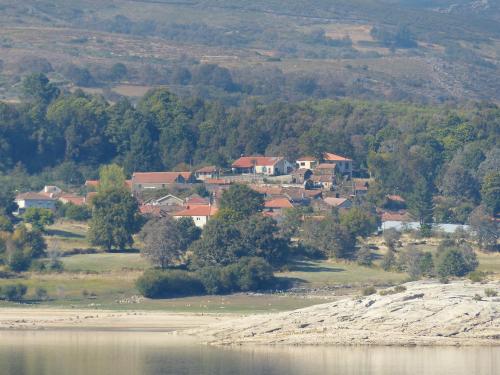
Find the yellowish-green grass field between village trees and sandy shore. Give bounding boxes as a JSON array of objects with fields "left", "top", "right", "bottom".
[{"left": 0, "top": 221, "right": 500, "bottom": 314}]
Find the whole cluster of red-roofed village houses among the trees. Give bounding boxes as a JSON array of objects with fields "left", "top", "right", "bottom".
[{"left": 15, "top": 153, "right": 408, "bottom": 228}]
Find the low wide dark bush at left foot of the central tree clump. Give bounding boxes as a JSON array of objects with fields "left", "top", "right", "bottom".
[{"left": 136, "top": 270, "right": 205, "bottom": 298}]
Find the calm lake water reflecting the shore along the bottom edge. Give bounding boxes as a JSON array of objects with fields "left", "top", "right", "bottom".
[{"left": 0, "top": 331, "right": 500, "bottom": 375}]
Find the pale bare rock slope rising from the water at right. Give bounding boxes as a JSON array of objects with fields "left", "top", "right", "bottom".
[{"left": 190, "top": 281, "right": 500, "bottom": 346}]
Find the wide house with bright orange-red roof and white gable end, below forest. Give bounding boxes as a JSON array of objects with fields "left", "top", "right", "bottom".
[{"left": 231, "top": 156, "right": 293, "bottom": 176}]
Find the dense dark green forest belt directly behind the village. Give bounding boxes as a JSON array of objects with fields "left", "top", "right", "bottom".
[{"left": 0, "top": 74, "right": 500, "bottom": 226}]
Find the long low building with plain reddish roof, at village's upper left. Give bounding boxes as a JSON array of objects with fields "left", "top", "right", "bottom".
[{"left": 132, "top": 172, "right": 196, "bottom": 193}]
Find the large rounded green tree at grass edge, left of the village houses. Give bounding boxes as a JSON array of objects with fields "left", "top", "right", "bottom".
[{"left": 88, "top": 189, "right": 142, "bottom": 251}]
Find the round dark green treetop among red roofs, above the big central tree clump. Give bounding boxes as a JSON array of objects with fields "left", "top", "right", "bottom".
[{"left": 219, "top": 184, "right": 264, "bottom": 218}]
